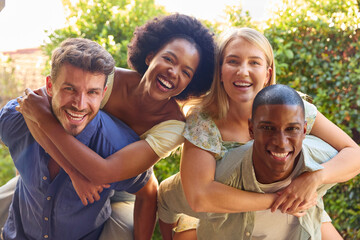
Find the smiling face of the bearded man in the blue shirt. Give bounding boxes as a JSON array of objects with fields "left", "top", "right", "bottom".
[{"left": 46, "top": 63, "right": 106, "bottom": 136}]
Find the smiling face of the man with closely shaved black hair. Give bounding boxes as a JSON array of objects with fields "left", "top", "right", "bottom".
[{"left": 249, "top": 104, "right": 306, "bottom": 183}]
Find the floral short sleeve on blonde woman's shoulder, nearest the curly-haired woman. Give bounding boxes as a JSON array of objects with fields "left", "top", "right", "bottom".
[{"left": 183, "top": 109, "right": 222, "bottom": 154}]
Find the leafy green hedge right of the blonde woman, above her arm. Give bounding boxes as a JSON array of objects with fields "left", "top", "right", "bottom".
[{"left": 264, "top": 0, "right": 360, "bottom": 143}]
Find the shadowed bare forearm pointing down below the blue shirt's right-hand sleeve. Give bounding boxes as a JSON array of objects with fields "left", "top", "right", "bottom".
[{"left": 134, "top": 174, "right": 158, "bottom": 240}]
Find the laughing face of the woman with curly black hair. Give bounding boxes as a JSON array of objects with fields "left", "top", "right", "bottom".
[{"left": 142, "top": 38, "right": 200, "bottom": 100}]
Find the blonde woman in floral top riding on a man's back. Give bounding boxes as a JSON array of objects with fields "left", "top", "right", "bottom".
[{"left": 158, "top": 28, "right": 360, "bottom": 239}]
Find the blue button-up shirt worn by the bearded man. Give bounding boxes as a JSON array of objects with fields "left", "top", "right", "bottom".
[{"left": 0, "top": 100, "right": 152, "bottom": 240}]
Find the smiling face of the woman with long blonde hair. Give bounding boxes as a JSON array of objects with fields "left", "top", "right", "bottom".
[{"left": 221, "top": 37, "right": 272, "bottom": 103}]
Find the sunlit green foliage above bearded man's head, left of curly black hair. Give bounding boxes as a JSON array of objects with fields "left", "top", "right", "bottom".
[{"left": 43, "top": 0, "right": 165, "bottom": 73}]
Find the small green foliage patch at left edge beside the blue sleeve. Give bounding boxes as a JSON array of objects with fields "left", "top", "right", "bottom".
[{"left": 0, "top": 142, "right": 16, "bottom": 186}]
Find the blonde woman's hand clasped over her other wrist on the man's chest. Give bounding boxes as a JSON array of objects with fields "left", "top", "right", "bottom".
[{"left": 271, "top": 170, "right": 321, "bottom": 213}]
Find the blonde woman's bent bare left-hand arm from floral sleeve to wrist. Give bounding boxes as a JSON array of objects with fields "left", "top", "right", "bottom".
[{"left": 180, "top": 140, "right": 276, "bottom": 213}]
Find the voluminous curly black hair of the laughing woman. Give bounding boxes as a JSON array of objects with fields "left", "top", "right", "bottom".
[{"left": 128, "top": 13, "right": 215, "bottom": 100}]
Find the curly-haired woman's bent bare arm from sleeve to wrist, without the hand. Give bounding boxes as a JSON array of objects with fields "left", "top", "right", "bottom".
[{"left": 41, "top": 114, "right": 159, "bottom": 184}]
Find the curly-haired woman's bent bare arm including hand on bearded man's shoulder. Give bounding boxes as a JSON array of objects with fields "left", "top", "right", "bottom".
[{"left": 22, "top": 89, "right": 159, "bottom": 184}]
